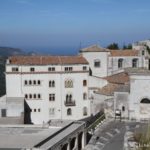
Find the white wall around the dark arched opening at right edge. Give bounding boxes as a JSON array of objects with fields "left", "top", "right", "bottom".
[{"left": 129, "top": 75, "right": 150, "bottom": 120}]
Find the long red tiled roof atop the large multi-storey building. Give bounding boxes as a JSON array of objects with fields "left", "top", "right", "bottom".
[{"left": 9, "top": 56, "right": 88, "bottom": 65}]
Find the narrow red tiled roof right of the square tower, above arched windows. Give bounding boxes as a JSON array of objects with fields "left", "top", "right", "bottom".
[{"left": 110, "top": 49, "right": 138, "bottom": 57}]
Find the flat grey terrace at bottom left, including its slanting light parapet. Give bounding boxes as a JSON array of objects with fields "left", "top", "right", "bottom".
[{"left": 0, "top": 121, "right": 84, "bottom": 149}]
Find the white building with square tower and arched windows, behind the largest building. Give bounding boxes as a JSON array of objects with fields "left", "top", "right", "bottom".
[{"left": 80, "top": 45, "right": 148, "bottom": 77}]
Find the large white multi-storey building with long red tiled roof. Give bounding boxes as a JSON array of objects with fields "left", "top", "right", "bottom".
[{"left": 6, "top": 56, "right": 91, "bottom": 124}]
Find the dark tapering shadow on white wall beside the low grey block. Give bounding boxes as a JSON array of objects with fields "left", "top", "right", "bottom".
[{"left": 24, "top": 101, "right": 33, "bottom": 124}]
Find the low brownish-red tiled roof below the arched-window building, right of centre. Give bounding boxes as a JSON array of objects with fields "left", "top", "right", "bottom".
[{"left": 104, "top": 72, "right": 129, "bottom": 84}]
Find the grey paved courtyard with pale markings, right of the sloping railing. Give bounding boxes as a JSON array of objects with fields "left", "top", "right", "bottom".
[{"left": 86, "top": 120, "right": 144, "bottom": 150}]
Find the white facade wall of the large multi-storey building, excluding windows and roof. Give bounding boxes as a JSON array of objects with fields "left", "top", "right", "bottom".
[{"left": 6, "top": 64, "right": 91, "bottom": 124}]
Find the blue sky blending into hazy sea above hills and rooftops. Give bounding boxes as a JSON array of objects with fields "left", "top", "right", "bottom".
[{"left": 0, "top": 0, "right": 150, "bottom": 54}]
